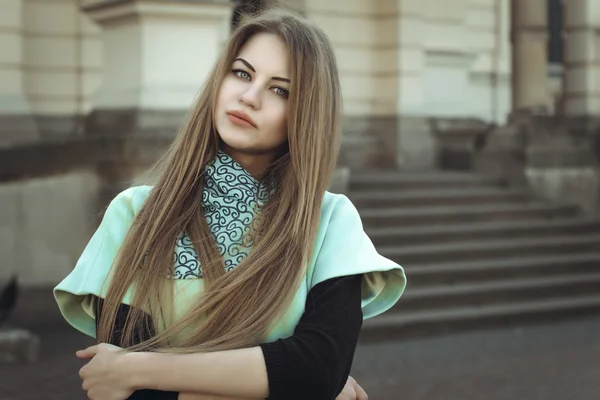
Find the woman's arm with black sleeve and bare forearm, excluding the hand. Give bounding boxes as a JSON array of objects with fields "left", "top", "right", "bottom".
[{"left": 124, "top": 275, "right": 362, "bottom": 400}]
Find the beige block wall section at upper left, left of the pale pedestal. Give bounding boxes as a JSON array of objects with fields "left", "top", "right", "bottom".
[{"left": 23, "top": 0, "right": 102, "bottom": 116}]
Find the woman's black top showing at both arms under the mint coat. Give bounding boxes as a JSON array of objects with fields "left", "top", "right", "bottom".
[{"left": 96, "top": 275, "right": 362, "bottom": 400}]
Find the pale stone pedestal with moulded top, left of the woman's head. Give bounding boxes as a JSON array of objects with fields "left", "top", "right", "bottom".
[{"left": 84, "top": 0, "right": 233, "bottom": 135}]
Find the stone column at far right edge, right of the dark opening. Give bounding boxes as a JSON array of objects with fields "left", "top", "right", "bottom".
[{"left": 563, "top": 0, "right": 600, "bottom": 116}]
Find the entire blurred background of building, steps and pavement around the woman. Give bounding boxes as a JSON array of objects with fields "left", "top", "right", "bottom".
[{"left": 0, "top": 0, "right": 600, "bottom": 400}]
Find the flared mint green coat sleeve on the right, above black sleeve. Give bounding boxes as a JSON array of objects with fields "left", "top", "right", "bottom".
[{"left": 307, "top": 195, "right": 406, "bottom": 319}]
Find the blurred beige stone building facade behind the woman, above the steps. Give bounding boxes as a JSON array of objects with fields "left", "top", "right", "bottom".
[{"left": 0, "top": 0, "right": 600, "bottom": 285}]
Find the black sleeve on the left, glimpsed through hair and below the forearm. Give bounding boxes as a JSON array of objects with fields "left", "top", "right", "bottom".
[{"left": 96, "top": 298, "right": 179, "bottom": 400}]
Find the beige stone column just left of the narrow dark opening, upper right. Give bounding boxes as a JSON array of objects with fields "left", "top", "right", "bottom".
[{"left": 511, "top": 0, "right": 548, "bottom": 114}]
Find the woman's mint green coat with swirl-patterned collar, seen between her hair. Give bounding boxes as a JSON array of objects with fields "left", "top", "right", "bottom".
[{"left": 54, "top": 153, "right": 406, "bottom": 342}]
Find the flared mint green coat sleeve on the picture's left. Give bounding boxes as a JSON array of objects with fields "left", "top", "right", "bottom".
[{"left": 53, "top": 187, "right": 149, "bottom": 337}]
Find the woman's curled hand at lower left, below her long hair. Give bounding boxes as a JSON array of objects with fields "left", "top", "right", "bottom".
[{"left": 76, "top": 343, "right": 134, "bottom": 400}]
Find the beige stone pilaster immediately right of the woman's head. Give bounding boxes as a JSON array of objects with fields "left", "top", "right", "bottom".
[{"left": 304, "top": 0, "right": 398, "bottom": 169}]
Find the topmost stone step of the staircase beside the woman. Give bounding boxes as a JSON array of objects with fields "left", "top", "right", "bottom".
[{"left": 349, "top": 171, "right": 505, "bottom": 193}]
